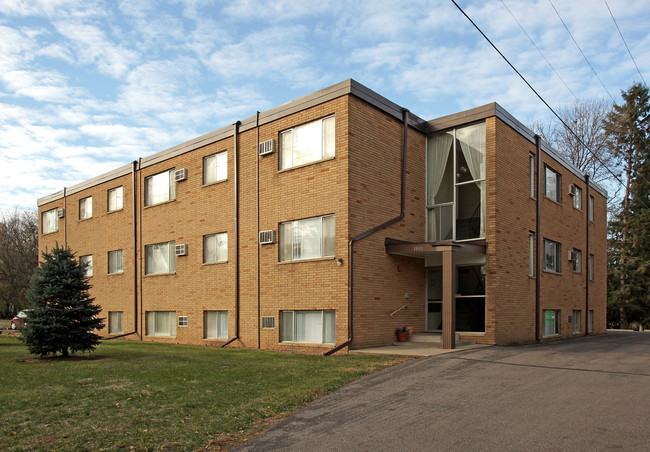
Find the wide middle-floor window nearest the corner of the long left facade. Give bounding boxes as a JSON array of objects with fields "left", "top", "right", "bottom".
[{"left": 280, "top": 215, "right": 334, "bottom": 261}]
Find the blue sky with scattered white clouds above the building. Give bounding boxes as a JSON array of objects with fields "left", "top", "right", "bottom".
[{"left": 0, "top": 0, "right": 650, "bottom": 209}]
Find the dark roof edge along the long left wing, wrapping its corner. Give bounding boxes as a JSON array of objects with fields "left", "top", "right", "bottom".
[{"left": 36, "top": 79, "right": 427, "bottom": 207}]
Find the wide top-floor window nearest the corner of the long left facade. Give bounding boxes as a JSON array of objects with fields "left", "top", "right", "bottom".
[{"left": 280, "top": 116, "right": 335, "bottom": 169}]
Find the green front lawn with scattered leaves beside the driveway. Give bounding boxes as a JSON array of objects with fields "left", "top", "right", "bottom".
[{"left": 0, "top": 336, "right": 402, "bottom": 451}]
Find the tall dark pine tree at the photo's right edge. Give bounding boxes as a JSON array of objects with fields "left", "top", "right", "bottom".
[{"left": 606, "top": 83, "right": 650, "bottom": 328}]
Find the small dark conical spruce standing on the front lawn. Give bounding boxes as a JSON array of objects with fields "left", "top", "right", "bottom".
[{"left": 22, "top": 245, "right": 104, "bottom": 357}]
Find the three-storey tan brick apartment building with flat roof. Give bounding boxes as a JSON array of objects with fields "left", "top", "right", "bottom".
[{"left": 38, "top": 80, "right": 606, "bottom": 353}]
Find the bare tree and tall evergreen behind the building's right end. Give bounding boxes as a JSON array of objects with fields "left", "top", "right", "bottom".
[{"left": 531, "top": 83, "right": 650, "bottom": 328}]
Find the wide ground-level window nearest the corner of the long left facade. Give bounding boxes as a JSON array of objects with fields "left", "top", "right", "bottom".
[{"left": 280, "top": 311, "right": 336, "bottom": 344}]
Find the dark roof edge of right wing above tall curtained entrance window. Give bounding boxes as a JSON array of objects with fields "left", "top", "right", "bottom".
[{"left": 427, "top": 102, "right": 607, "bottom": 198}]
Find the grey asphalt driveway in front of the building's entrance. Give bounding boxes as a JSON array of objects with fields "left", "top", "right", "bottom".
[{"left": 238, "top": 332, "right": 650, "bottom": 451}]
